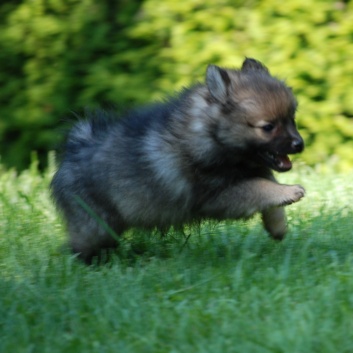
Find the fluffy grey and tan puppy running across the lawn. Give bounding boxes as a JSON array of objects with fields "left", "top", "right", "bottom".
[{"left": 51, "top": 59, "right": 304, "bottom": 262}]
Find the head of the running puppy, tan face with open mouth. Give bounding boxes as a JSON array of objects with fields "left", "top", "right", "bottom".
[{"left": 206, "top": 59, "right": 304, "bottom": 172}]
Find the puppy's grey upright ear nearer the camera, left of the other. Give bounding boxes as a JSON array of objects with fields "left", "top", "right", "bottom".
[{"left": 206, "top": 65, "right": 230, "bottom": 102}]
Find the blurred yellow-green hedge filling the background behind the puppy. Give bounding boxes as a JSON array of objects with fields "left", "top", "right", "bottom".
[{"left": 0, "top": 0, "right": 353, "bottom": 170}]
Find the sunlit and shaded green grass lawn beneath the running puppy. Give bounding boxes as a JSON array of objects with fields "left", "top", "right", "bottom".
[{"left": 0, "top": 158, "right": 353, "bottom": 353}]
